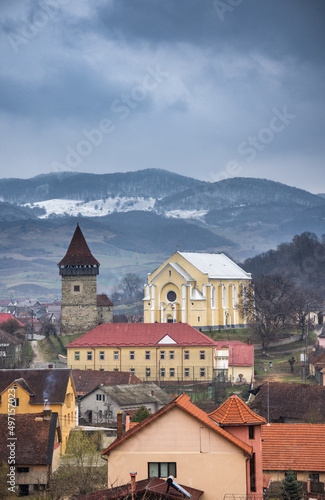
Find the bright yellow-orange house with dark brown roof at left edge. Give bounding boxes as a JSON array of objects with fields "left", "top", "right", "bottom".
[{"left": 0, "top": 369, "right": 78, "bottom": 453}]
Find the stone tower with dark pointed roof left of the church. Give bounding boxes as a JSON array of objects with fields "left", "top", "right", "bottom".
[{"left": 58, "top": 224, "right": 100, "bottom": 335}]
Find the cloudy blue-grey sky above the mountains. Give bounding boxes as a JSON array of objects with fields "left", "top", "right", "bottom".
[{"left": 0, "top": 0, "right": 325, "bottom": 193}]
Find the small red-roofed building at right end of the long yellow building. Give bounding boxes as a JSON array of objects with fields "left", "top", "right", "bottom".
[{"left": 216, "top": 340, "right": 254, "bottom": 385}]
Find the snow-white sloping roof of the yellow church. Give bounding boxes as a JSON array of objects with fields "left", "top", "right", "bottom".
[{"left": 177, "top": 252, "right": 251, "bottom": 280}]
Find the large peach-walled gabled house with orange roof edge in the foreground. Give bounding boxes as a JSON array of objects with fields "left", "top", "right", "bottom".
[{"left": 103, "top": 394, "right": 262, "bottom": 500}]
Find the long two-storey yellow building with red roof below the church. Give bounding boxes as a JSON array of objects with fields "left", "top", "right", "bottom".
[{"left": 66, "top": 323, "right": 216, "bottom": 383}]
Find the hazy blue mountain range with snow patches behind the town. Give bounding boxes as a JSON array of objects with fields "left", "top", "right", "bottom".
[{"left": 0, "top": 169, "right": 325, "bottom": 296}]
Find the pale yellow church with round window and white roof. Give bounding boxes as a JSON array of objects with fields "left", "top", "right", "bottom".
[{"left": 143, "top": 252, "right": 251, "bottom": 329}]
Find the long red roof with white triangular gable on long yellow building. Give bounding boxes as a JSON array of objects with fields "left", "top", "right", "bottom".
[{"left": 66, "top": 323, "right": 215, "bottom": 348}]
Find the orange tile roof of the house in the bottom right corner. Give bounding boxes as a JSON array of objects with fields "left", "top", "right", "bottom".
[{"left": 262, "top": 424, "right": 325, "bottom": 471}]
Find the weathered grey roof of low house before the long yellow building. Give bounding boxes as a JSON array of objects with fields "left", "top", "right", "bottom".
[{"left": 101, "top": 382, "right": 171, "bottom": 406}]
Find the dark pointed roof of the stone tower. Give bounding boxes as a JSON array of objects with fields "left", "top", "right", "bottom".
[{"left": 58, "top": 225, "right": 100, "bottom": 266}]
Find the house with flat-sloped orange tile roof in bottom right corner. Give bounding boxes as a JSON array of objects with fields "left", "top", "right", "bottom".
[{"left": 262, "top": 424, "right": 325, "bottom": 494}]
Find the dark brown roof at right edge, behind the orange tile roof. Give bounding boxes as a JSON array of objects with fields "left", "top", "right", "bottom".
[{"left": 250, "top": 382, "right": 325, "bottom": 423}]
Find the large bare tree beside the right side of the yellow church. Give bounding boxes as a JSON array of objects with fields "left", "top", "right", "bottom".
[{"left": 240, "top": 275, "right": 294, "bottom": 352}]
